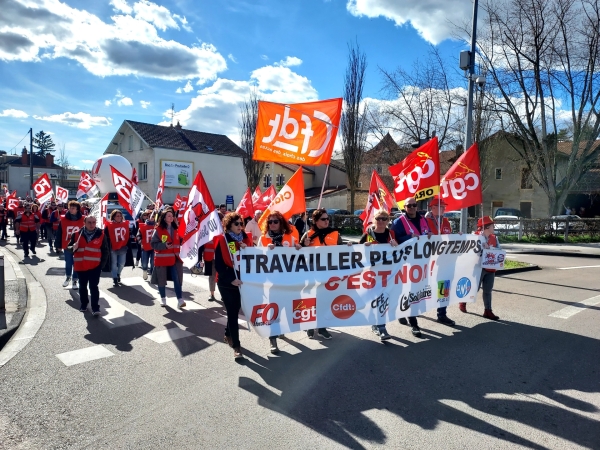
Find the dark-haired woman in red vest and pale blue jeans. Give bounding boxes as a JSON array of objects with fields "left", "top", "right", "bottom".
[{"left": 150, "top": 208, "right": 185, "bottom": 308}]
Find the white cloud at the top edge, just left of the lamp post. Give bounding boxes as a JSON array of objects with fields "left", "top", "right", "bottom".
[{"left": 346, "top": 0, "right": 473, "bottom": 45}]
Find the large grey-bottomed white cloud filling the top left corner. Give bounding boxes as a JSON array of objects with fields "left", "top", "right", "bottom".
[{"left": 0, "top": 0, "right": 227, "bottom": 83}]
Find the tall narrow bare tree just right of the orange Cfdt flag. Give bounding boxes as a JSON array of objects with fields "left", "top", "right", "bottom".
[{"left": 340, "top": 43, "right": 368, "bottom": 211}]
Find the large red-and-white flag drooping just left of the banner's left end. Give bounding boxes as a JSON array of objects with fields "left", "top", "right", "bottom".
[{"left": 178, "top": 171, "right": 223, "bottom": 268}]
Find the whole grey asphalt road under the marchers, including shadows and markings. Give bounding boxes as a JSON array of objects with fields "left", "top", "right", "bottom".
[{"left": 0, "top": 241, "right": 600, "bottom": 449}]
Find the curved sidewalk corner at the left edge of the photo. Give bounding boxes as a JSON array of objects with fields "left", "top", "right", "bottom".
[{"left": 0, "top": 247, "right": 27, "bottom": 349}]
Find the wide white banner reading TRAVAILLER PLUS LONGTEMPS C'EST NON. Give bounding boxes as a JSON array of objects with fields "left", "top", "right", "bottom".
[{"left": 240, "top": 234, "right": 483, "bottom": 337}]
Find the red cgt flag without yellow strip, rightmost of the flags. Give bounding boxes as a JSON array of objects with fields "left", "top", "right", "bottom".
[{"left": 441, "top": 143, "right": 483, "bottom": 211}]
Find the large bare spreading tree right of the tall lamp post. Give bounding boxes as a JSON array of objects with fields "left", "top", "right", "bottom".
[{"left": 478, "top": 0, "right": 600, "bottom": 214}]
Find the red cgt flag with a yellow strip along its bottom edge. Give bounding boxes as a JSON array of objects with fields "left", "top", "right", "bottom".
[{"left": 389, "top": 137, "right": 440, "bottom": 208}]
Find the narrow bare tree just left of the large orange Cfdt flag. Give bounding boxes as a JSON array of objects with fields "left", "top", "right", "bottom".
[{"left": 239, "top": 91, "right": 265, "bottom": 192}]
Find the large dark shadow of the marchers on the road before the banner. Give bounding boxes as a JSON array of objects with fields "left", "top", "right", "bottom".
[{"left": 239, "top": 322, "right": 600, "bottom": 448}]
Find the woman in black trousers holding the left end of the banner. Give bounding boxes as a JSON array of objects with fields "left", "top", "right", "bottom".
[{"left": 214, "top": 212, "right": 252, "bottom": 359}]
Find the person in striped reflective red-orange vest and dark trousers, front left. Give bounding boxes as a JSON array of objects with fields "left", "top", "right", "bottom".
[{"left": 65, "top": 216, "right": 110, "bottom": 316}]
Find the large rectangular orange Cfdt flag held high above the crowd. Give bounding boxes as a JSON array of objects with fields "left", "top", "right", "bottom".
[{"left": 253, "top": 98, "right": 342, "bottom": 166}]
